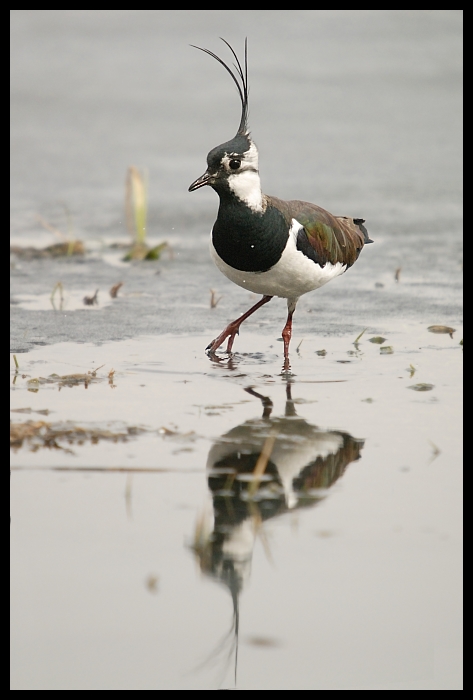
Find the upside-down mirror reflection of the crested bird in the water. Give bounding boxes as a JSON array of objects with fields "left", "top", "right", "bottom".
[{"left": 190, "top": 382, "right": 364, "bottom": 686}]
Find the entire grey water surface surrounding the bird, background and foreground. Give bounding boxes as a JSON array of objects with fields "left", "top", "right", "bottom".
[{"left": 10, "top": 10, "right": 463, "bottom": 689}]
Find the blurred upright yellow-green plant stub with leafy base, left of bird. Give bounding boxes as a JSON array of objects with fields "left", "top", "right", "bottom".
[{"left": 124, "top": 165, "right": 167, "bottom": 260}]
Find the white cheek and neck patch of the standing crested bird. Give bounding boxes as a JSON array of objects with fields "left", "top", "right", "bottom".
[{"left": 222, "top": 143, "right": 263, "bottom": 212}]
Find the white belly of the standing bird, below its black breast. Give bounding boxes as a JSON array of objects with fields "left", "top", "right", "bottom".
[{"left": 210, "top": 219, "right": 347, "bottom": 299}]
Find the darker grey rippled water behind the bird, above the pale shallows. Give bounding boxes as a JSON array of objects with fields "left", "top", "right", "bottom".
[{"left": 12, "top": 10, "right": 462, "bottom": 351}]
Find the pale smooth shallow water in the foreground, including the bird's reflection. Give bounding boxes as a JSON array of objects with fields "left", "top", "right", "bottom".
[{"left": 11, "top": 326, "right": 461, "bottom": 688}]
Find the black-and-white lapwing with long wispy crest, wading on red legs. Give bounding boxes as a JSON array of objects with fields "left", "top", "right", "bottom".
[{"left": 189, "top": 37, "right": 372, "bottom": 373}]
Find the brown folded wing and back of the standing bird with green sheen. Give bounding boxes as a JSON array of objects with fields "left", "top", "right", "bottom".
[{"left": 268, "top": 197, "right": 369, "bottom": 267}]
